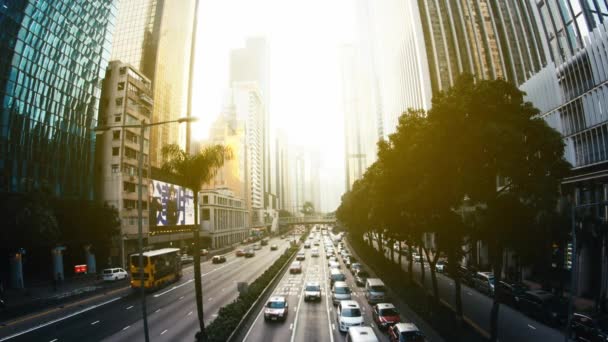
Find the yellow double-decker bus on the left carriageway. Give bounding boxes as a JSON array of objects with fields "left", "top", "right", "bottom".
[{"left": 130, "top": 248, "right": 182, "bottom": 290}]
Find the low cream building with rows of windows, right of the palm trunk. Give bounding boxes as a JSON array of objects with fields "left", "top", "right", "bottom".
[{"left": 199, "top": 189, "right": 250, "bottom": 248}]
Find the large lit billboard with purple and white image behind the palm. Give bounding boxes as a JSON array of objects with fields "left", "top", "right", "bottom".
[{"left": 148, "top": 179, "right": 194, "bottom": 227}]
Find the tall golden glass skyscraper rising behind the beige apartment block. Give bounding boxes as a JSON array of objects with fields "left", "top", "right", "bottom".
[{"left": 112, "top": 0, "right": 194, "bottom": 167}]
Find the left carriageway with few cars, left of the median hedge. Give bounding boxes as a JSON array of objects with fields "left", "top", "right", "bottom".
[{"left": 0, "top": 235, "right": 288, "bottom": 342}]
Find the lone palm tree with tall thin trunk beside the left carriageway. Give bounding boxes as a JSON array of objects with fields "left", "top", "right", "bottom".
[{"left": 162, "top": 144, "right": 232, "bottom": 341}]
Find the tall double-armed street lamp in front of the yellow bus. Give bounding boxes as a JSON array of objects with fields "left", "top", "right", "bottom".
[{"left": 94, "top": 116, "right": 198, "bottom": 342}]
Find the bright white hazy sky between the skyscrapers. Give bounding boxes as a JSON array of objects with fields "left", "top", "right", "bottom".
[{"left": 193, "top": 0, "right": 354, "bottom": 211}]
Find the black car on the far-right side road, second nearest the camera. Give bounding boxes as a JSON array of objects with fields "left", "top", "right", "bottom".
[{"left": 519, "top": 290, "right": 568, "bottom": 326}]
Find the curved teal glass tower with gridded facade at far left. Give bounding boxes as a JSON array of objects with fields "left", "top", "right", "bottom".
[{"left": 0, "top": 0, "right": 116, "bottom": 199}]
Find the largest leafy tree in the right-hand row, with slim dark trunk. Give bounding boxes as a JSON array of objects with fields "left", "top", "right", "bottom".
[{"left": 428, "top": 75, "right": 569, "bottom": 341}]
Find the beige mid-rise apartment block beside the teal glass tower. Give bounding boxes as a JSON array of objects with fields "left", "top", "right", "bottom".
[{"left": 95, "top": 61, "right": 154, "bottom": 266}]
